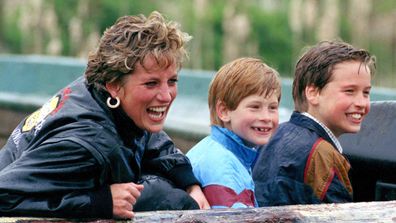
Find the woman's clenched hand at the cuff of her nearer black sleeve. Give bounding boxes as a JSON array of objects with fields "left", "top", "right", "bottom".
[{"left": 110, "top": 183, "right": 143, "bottom": 219}]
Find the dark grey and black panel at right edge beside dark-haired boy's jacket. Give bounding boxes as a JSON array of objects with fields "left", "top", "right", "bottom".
[{"left": 340, "top": 100, "right": 396, "bottom": 202}]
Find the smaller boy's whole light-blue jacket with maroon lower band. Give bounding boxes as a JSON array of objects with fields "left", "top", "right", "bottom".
[{"left": 187, "top": 126, "right": 257, "bottom": 208}]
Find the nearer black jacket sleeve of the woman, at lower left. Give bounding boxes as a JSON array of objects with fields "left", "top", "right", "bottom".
[{"left": 0, "top": 137, "right": 112, "bottom": 218}]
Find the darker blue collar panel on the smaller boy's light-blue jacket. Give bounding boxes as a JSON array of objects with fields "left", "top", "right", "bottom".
[{"left": 211, "top": 125, "right": 257, "bottom": 170}]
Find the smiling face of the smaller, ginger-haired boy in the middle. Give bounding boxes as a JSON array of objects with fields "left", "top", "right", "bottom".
[{"left": 220, "top": 93, "right": 279, "bottom": 146}]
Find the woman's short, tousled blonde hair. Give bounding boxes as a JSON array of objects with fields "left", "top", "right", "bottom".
[{"left": 85, "top": 11, "right": 191, "bottom": 90}]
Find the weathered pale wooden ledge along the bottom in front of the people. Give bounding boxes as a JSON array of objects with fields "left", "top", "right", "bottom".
[{"left": 0, "top": 201, "right": 396, "bottom": 223}]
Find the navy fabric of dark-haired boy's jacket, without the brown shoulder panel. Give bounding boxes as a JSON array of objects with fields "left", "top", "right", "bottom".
[{"left": 253, "top": 112, "right": 352, "bottom": 206}]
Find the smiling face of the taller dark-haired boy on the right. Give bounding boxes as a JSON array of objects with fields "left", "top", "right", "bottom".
[{"left": 306, "top": 61, "right": 371, "bottom": 137}]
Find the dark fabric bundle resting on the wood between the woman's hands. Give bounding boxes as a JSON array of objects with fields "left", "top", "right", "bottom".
[{"left": 133, "top": 175, "right": 199, "bottom": 212}]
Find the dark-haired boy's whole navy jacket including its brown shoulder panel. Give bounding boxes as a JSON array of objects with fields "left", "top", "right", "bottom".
[{"left": 253, "top": 112, "right": 352, "bottom": 206}]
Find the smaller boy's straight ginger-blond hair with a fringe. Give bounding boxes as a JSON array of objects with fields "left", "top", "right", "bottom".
[{"left": 208, "top": 57, "right": 281, "bottom": 127}]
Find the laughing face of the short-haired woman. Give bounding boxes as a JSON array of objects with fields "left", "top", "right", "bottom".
[{"left": 106, "top": 57, "right": 178, "bottom": 132}]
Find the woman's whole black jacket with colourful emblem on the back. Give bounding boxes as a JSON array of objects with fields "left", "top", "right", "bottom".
[{"left": 0, "top": 77, "right": 199, "bottom": 218}]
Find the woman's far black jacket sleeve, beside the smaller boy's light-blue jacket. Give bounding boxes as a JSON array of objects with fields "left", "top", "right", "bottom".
[{"left": 142, "top": 131, "right": 199, "bottom": 189}]
